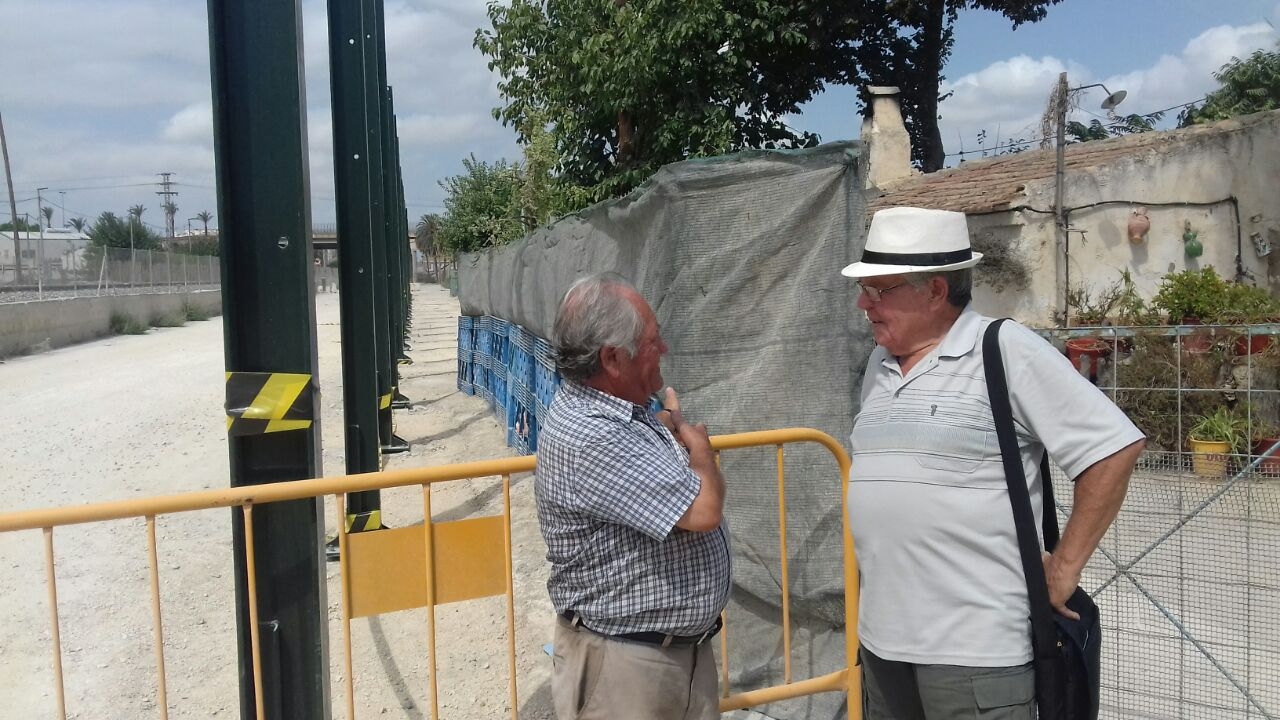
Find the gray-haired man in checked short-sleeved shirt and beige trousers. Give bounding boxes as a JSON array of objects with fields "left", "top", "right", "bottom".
[{"left": 535, "top": 274, "right": 731, "bottom": 720}]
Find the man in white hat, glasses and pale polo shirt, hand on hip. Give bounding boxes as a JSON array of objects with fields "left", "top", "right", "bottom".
[{"left": 842, "top": 208, "right": 1144, "bottom": 720}]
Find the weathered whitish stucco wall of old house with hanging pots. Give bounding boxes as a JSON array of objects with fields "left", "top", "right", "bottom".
[{"left": 969, "top": 111, "right": 1280, "bottom": 324}]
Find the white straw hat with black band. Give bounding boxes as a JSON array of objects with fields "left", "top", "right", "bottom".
[{"left": 840, "top": 208, "right": 982, "bottom": 278}]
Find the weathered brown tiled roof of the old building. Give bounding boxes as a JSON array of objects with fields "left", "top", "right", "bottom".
[{"left": 867, "top": 110, "right": 1280, "bottom": 213}]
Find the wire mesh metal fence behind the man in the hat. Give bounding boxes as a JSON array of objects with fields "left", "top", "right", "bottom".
[{"left": 1043, "top": 325, "right": 1280, "bottom": 720}]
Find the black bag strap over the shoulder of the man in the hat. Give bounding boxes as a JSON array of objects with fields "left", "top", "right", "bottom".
[{"left": 982, "top": 318, "right": 1059, "bottom": 657}]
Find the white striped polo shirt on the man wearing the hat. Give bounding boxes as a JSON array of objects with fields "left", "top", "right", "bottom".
[{"left": 849, "top": 309, "right": 1143, "bottom": 667}]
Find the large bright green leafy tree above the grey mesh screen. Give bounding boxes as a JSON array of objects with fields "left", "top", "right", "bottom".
[{"left": 475, "top": 0, "right": 826, "bottom": 196}]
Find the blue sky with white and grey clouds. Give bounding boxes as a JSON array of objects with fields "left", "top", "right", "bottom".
[{"left": 0, "top": 0, "right": 1280, "bottom": 232}]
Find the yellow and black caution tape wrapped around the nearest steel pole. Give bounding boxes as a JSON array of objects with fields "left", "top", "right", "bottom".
[{"left": 227, "top": 373, "right": 315, "bottom": 436}]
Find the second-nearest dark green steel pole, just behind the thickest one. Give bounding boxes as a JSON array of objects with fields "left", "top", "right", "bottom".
[{"left": 329, "top": 0, "right": 381, "bottom": 497}]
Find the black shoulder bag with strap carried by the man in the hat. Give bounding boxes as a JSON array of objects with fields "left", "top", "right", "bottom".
[{"left": 982, "top": 318, "right": 1102, "bottom": 720}]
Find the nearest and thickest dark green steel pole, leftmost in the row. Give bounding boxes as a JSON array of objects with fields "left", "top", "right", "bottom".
[{"left": 209, "top": 0, "right": 329, "bottom": 720}]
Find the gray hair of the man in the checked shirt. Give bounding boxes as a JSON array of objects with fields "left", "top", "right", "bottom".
[{"left": 552, "top": 273, "right": 644, "bottom": 382}]
